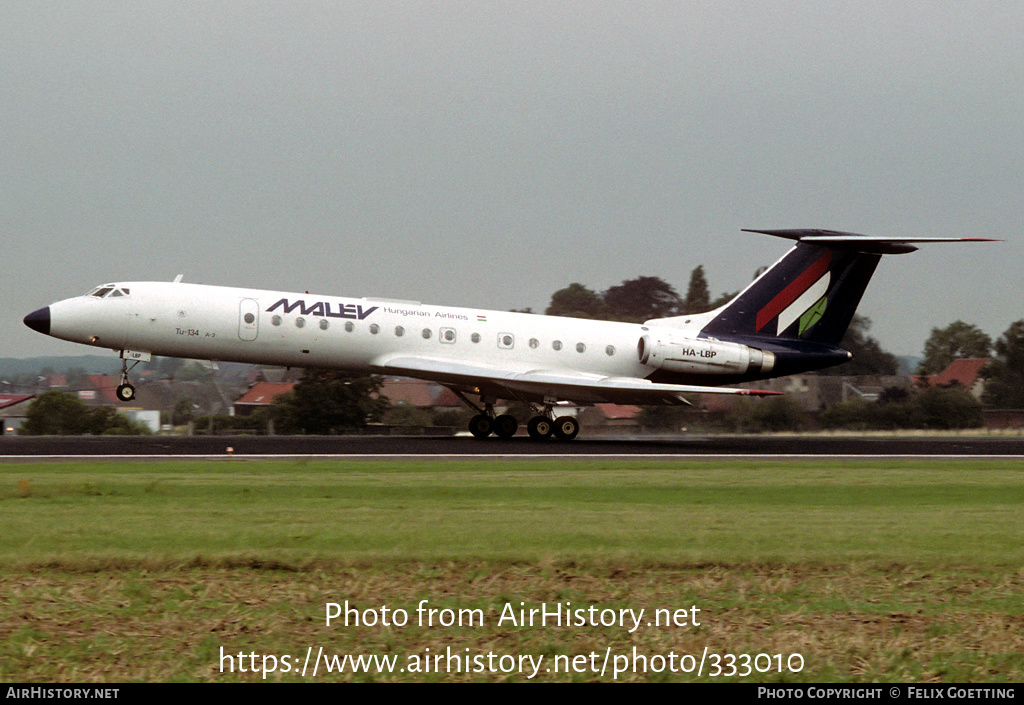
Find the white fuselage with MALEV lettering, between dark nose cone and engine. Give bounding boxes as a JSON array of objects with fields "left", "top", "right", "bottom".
[{"left": 49, "top": 282, "right": 678, "bottom": 377}]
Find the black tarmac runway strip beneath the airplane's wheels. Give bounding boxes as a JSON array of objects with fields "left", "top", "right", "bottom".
[{"left": 0, "top": 436, "right": 1024, "bottom": 459}]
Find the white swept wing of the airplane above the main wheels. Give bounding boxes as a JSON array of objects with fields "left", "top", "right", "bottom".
[{"left": 374, "top": 356, "right": 781, "bottom": 405}]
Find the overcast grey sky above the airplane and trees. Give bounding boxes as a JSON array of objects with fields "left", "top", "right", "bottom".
[{"left": 0, "top": 0, "right": 1024, "bottom": 357}]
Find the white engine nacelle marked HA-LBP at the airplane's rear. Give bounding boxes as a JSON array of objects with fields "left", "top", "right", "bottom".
[{"left": 637, "top": 331, "right": 775, "bottom": 375}]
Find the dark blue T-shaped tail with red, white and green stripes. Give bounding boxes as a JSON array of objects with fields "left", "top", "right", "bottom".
[{"left": 688, "top": 230, "right": 982, "bottom": 345}]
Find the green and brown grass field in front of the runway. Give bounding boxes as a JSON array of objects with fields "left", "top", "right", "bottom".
[{"left": 0, "top": 459, "right": 1024, "bottom": 681}]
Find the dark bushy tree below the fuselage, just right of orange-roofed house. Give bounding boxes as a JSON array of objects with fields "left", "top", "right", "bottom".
[{"left": 273, "top": 370, "right": 388, "bottom": 434}]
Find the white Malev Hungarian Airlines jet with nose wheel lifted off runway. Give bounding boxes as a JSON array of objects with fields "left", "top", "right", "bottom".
[{"left": 25, "top": 230, "right": 991, "bottom": 441}]
